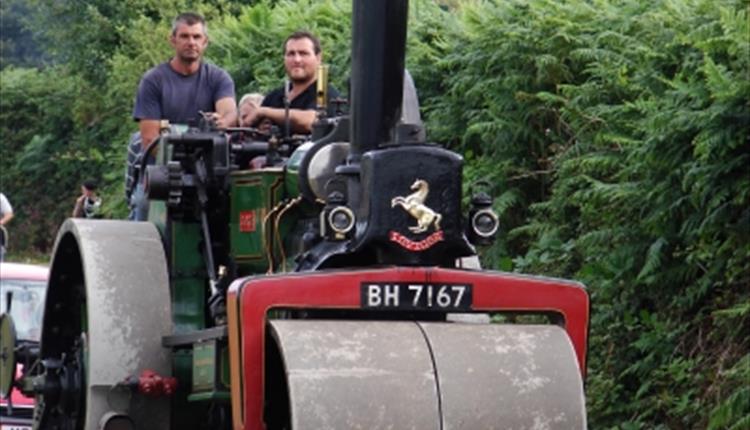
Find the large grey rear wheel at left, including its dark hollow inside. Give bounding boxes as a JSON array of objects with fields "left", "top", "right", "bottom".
[{"left": 42, "top": 219, "right": 172, "bottom": 430}]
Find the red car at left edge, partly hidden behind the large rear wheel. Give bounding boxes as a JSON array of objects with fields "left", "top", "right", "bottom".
[{"left": 0, "top": 263, "right": 48, "bottom": 430}]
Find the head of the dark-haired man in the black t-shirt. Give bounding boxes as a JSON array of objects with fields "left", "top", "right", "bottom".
[{"left": 284, "top": 31, "right": 322, "bottom": 84}]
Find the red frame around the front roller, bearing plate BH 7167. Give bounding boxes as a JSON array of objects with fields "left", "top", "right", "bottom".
[{"left": 229, "top": 267, "right": 589, "bottom": 429}]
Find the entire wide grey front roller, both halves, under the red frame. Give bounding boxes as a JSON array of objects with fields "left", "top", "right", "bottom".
[{"left": 267, "top": 320, "right": 586, "bottom": 430}]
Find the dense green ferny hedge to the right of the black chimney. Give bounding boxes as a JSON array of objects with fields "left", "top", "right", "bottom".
[{"left": 430, "top": 1, "right": 750, "bottom": 428}]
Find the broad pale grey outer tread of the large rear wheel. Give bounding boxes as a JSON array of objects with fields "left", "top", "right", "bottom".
[{"left": 64, "top": 219, "right": 172, "bottom": 430}]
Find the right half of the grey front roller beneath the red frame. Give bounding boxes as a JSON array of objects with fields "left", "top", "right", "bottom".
[{"left": 419, "top": 322, "right": 586, "bottom": 430}]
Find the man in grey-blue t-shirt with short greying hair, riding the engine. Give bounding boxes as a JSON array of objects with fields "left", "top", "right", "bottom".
[{"left": 129, "top": 13, "right": 237, "bottom": 220}]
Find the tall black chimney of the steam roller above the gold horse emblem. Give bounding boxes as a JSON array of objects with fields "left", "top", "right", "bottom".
[{"left": 350, "top": 0, "right": 409, "bottom": 157}]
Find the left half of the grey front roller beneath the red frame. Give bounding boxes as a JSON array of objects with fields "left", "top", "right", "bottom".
[{"left": 271, "top": 320, "right": 439, "bottom": 430}]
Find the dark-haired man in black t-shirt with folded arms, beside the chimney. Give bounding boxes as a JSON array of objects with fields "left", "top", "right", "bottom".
[{"left": 249, "top": 31, "right": 339, "bottom": 134}]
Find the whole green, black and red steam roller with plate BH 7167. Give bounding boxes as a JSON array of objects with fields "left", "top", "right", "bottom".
[{"left": 0, "top": 0, "right": 589, "bottom": 430}]
